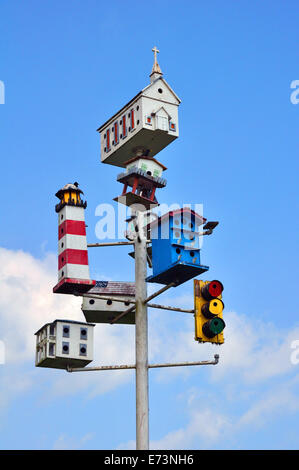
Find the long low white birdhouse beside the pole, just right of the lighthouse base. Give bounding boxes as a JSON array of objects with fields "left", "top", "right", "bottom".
[{"left": 81, "top": 281, "right": 135, "bottom": 325}]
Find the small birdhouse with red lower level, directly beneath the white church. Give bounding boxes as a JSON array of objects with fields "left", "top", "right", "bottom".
[{"left": 114, "top": 155, "right": 167, "bottom": 210}]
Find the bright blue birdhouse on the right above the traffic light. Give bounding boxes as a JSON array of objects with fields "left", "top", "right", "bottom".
[{"left": 146, "top": 209, "right": 209, "bottom": 285}]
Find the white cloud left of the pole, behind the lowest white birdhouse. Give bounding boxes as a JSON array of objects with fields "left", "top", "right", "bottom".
[{"left": 0, "top": 248, "right": 134, "bottom": 406}]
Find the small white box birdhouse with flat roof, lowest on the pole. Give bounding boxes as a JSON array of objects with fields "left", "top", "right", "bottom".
[{"left": 35, "top": 320, "right": 95, "bottom": 369}]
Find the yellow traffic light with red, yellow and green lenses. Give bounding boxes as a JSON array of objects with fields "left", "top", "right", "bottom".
[{"left": 194, "top": 279, "right": 225, "bottom": 344}]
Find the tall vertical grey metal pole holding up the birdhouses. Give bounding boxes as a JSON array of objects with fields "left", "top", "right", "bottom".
[{"left": 135, "top": 212, "right": 149, "bottom": 450}]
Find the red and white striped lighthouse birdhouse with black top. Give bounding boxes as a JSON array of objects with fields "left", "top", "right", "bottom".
[{"left": 53, "top": 183, "right": 95, "bottom": 294}]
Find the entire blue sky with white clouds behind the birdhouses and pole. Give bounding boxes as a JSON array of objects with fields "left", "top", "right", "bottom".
[{"left": 0, "top": 0, "right": 299, "bottom": 449}]
